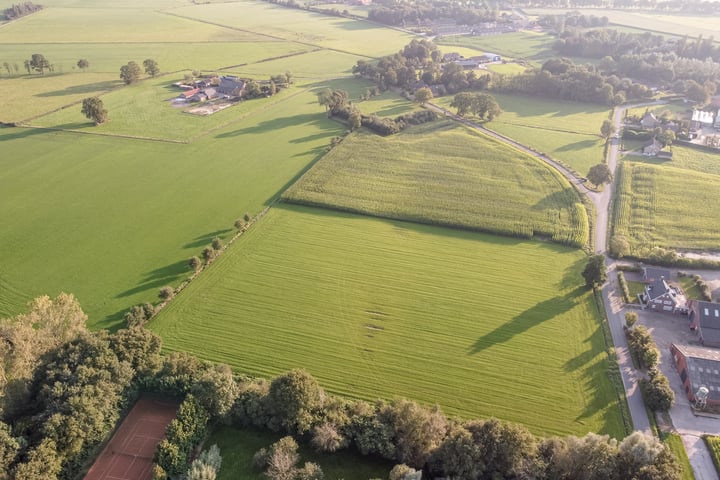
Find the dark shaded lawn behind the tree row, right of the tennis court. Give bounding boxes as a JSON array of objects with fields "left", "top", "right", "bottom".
[{"left": 205, "top": 426, "right": 393, "bottom": 480}]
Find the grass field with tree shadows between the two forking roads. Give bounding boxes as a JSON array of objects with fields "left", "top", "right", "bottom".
[{"left": 433, "top": 94, "right": 610, "bottom": 175}]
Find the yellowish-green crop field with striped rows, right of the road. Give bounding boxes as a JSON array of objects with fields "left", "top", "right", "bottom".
[{"left": 613, "top": 157, "right": 720, "bottom": 256}]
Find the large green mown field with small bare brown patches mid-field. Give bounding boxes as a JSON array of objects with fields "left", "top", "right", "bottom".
[{"left": 150, "top": 205, "right": 624, "bottom": 435}]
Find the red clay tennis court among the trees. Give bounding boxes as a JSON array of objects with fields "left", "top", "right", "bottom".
[{"left": 85, "top": 397, "right": 178, "bottom": 480}]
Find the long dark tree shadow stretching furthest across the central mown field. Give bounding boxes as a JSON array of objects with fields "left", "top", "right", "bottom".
[{"left": 468, "top": 289, "right": 578, "bottom": 355}]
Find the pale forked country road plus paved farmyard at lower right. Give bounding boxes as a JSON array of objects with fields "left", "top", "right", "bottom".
[{"left": 427, "top": 102, "right": 720, "bottom": 480}]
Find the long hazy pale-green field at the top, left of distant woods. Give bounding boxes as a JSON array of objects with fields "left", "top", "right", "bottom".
[{"left": 167, "top": 1, "right": 416, "bottom": 57}]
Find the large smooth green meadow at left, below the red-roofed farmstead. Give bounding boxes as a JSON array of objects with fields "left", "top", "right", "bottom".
[{"left": 0, "top": 86, "right": 344, "bottom": 328}]
